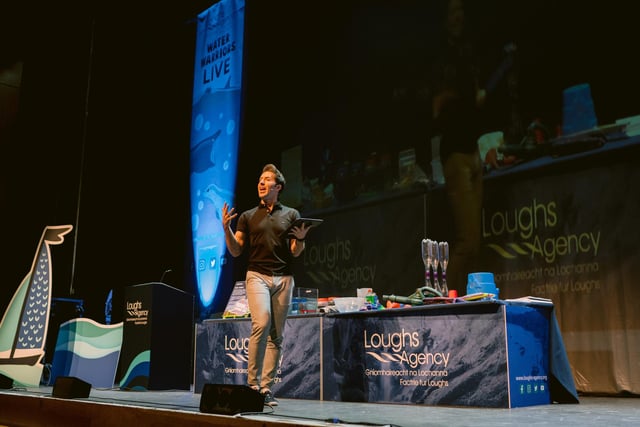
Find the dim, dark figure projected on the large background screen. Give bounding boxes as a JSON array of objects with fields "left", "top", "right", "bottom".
[{"left": 431, "top": 0, "right": 496, "bottom": 292}]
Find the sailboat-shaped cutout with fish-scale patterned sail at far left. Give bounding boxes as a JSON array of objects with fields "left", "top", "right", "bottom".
[{"left": 0, "top": 225, "right": 73, "bottom": 387}]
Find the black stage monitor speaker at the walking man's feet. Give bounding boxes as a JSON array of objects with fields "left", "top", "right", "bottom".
[{"left": 200, "top": 384, "right": 264, "bottom": 415}]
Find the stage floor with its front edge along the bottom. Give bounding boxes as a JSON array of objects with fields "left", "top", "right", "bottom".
[{"left": 0, "top": 387, "right": 640, "bottom": 427}]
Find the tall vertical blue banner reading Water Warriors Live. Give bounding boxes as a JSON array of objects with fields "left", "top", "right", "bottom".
[{"left": 190, "top": 0, "right": 245, "bottom": 315}]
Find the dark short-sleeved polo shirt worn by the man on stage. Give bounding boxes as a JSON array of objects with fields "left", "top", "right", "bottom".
[{"left": 237, "top": 202, "right": 300, "bottom": 276}]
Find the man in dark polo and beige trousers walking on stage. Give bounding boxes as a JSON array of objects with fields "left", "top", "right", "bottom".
[{"left": 222, "top": 164, "right": 309, "bottom": 406}]
